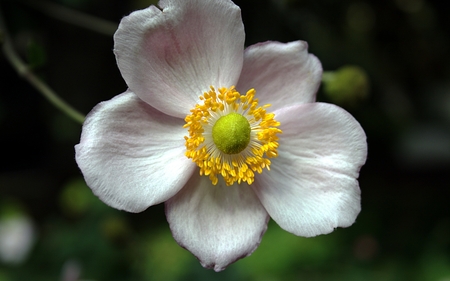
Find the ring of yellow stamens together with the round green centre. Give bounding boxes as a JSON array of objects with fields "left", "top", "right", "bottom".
[{"left": 184, "top": 86, "right": 282, "bottom": 185}]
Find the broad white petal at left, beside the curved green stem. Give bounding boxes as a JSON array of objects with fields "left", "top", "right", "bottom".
[{"left": 75, "top": 92, "right": 196, "bottom": 212}]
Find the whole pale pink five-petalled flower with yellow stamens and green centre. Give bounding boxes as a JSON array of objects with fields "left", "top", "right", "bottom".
[{"left": 75, "top": 0, "right": 367, "bottom": 271}]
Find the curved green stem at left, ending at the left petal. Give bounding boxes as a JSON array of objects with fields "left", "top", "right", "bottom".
[{"left": 0, "top": 9, "right": 85, "bottom": 124}]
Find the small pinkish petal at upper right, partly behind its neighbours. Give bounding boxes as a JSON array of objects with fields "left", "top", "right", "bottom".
[{"left": 236, "top": 41, "right": 322, "bottom": 110}]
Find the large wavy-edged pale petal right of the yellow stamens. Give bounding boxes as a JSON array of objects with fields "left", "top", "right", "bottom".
[{"left": 252, "top": 103, "right": 367, "bottom": 237}]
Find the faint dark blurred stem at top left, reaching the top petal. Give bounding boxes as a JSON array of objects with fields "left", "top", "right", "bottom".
[{"left": 16, "top": 0, "right": 118, "bottom": 36}]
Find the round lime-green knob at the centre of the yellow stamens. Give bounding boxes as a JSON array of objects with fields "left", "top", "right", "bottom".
[{"left": 212, "top": 112, "right": 251, "bottom": 154}]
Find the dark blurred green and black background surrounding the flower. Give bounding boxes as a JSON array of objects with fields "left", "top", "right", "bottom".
[{"left": 0, "top": 0, "right": 450, "bottom": 281}]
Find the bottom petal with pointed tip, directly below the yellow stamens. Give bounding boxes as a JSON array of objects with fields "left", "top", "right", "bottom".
[{"left": 166, "top": 175, "right": 269, "bottom": 271}]
